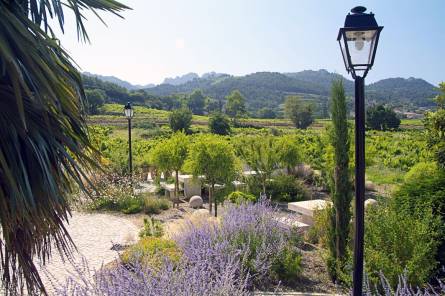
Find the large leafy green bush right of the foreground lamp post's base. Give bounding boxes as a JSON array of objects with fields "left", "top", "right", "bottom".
[{"left": 365, "top": 202, "right": 442, "bottom": 287}]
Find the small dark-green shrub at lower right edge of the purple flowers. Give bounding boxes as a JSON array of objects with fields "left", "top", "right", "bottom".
[{"left": 272, "top": 246, "right": 303, "bottom": 282}]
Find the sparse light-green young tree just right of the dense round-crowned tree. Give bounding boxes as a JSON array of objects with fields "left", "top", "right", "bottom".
[{"left": 236, "top": 137, "right": 281, "bottom": 194}]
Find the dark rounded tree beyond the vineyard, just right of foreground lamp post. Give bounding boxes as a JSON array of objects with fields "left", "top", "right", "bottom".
[{"left": 366, "top": 105, "right": 400, "bottom": 131}]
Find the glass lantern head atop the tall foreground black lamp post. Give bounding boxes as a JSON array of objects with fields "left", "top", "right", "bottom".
[{"left": 337, "top": 6, "right": 383, "bottom": 78}]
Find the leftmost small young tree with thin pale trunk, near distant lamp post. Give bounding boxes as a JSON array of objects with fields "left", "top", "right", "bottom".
[{"left": 151, "top": 132, "right": 189, "bottom": 203}]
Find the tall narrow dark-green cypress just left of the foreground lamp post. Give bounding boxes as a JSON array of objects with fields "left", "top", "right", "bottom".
[{"left": 329, "top": 80, "right": 352, "bottom": 279}]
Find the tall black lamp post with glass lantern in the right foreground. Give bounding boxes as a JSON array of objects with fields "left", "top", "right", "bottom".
[{"left": 337, "top": 6, "right": 383, "bottom": 296}]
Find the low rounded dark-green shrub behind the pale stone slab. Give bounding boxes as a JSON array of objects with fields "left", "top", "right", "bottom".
[{"left": 266, "top": 175, "right": 309, "bottom": 202}]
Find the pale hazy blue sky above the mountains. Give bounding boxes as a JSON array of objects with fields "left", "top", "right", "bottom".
[{"left": 55, "top": 0, "right": 445, "bottom": 84}]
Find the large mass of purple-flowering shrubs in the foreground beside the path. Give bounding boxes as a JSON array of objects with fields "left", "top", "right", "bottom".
[{"left": 57, "top": 200, "right": 301, "bottom": 296}]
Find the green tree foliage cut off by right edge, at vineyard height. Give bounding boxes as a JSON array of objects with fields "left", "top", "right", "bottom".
[{"left": 424, "top": 108, "right": 445, "bottom": 169}]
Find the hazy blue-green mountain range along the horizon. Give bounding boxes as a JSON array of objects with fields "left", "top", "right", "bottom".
[{"left": 85, "top": 70, "right": 438, "bottom": 114}]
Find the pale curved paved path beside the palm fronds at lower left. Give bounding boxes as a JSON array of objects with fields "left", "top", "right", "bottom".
[{"left": 41, "top": 212, "right": 139, "bottom": 293}]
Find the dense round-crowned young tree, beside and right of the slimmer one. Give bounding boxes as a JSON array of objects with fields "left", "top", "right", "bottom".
[{"left": 187, "top": 135, "right": 237, "bottom": 217}]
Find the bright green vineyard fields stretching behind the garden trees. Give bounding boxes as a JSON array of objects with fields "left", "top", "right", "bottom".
[{"left": 89, "top": 104, "right": 431, "bottom": 184}]
